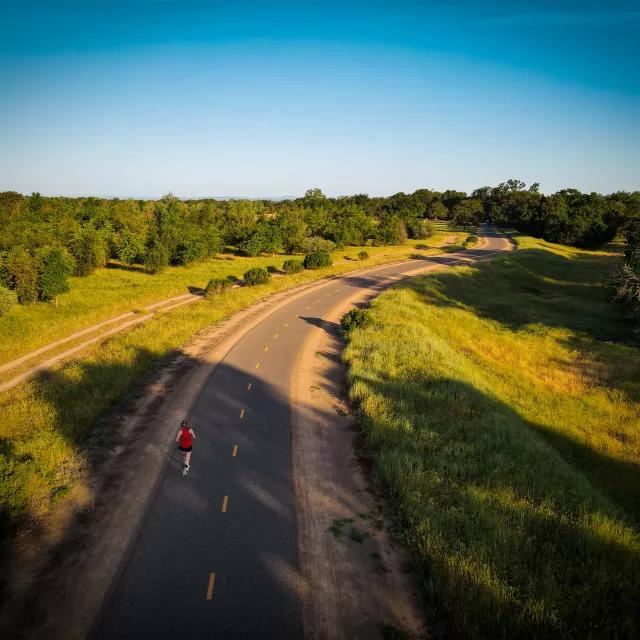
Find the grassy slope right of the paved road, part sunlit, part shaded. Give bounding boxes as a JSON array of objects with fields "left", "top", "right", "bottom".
[{"left": 345, "top": 237, "right": 640, "bottom": 639}]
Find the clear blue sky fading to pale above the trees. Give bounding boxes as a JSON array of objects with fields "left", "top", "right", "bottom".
[{"left": 0, "top": 0, "right": 640, "bottom": 198}]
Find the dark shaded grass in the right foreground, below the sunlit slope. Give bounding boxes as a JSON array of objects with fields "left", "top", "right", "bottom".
[{"left": 350, "top": 369, "right": 640, "bottom": 639}]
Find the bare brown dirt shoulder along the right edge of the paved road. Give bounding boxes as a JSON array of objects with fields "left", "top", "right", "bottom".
[{"left": 292, "top": 282, "right": 426, "bottom": 640}]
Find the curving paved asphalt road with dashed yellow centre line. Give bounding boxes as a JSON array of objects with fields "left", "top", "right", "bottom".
[{"left": 98, "top": 229, "right": 505, "bottom": 640}]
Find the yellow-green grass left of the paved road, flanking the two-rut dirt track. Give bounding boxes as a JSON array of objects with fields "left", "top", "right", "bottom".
[{"left": 0, "top": 226, "right": 459, "bottom": 536}]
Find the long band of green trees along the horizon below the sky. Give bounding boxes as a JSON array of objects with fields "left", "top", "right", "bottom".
[{"left": 0, "top": 180, "right": 640, "bottom": 312}]
